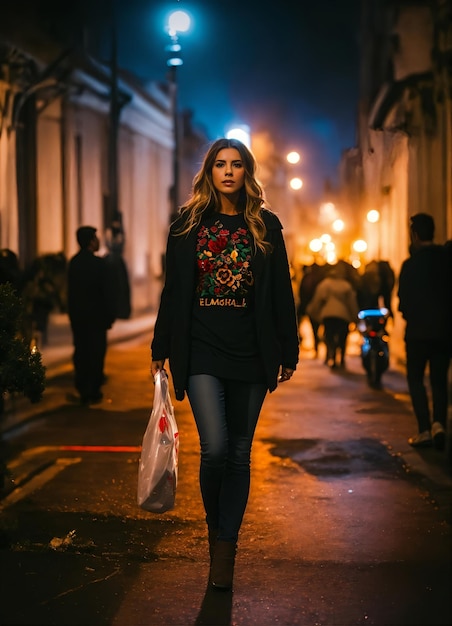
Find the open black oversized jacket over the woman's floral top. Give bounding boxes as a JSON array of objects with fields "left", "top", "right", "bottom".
[{"left": 151, "top": 209, "right": 299, "bottom": 400}]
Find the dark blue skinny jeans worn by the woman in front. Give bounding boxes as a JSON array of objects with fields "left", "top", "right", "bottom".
[{"left": 187, "top": 374, "right": 267, "bottom": 542}]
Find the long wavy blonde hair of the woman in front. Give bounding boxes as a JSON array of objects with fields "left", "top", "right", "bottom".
[{"left": 176, "top": 138, "right": 271, "bottom": 254}]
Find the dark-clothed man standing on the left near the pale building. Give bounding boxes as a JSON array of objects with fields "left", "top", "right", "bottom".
[{"left": 68, "top": 226, "right": 114, "bottom": 404}]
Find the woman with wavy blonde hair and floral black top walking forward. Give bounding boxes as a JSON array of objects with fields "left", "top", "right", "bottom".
[{"left": 151, "top": 139, "right": 298, "bottom": 589}]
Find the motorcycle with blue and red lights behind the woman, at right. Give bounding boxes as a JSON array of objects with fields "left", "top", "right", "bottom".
[{"left": 358, "top": 308, "right": 389, "bottom": 389}]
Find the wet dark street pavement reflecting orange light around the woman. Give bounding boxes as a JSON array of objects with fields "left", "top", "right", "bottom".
[{"left": 0, "top": 326, "right": 452, "bottom": 626}]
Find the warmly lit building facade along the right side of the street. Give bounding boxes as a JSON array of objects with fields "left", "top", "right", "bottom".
[{"left": 341, "top": 0, "right": 452, "bottom": 352}]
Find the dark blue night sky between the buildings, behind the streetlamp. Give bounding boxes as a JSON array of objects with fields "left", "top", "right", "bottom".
[{"left": 117, "top": 0, "right": 361, "bottom": 199}]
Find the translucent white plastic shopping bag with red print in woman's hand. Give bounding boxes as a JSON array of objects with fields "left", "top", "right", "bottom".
[{"left": 137, "top": 370, "right": 179, "bottom": 513}]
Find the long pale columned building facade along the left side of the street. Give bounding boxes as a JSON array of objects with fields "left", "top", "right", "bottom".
[{"left": 0, "top": 43, "right": 178, "bottom": 312}]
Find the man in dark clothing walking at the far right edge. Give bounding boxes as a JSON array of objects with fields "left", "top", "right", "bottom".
[{"left": 398, "top": 213, "right": 452, "bottom": 449}]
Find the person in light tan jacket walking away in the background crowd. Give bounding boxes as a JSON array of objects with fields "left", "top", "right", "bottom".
[{"left": 308, "top": 263, "right": 359, "bottom": 368}]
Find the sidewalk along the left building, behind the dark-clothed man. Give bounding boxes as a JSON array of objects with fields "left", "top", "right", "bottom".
[{"left": 0, "top": 313, "right": 155, "bottom": 435}]
